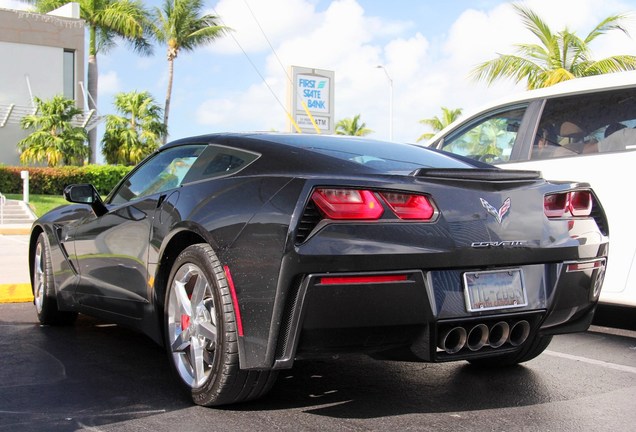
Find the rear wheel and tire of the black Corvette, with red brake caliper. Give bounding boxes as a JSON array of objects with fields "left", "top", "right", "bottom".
[{"left": 164, "top": 243, "right": 278, "bottom": 406}]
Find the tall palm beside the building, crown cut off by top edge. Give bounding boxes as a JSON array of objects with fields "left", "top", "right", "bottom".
[{"left": 31, "top": 0, "right": 152, "bottom": 163}]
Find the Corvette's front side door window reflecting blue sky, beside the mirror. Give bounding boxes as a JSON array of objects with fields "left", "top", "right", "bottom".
[{"left": 110, "top": 144, "right": 207, "bottom": 204}]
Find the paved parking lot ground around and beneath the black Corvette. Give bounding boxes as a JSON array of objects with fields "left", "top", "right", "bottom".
[{"left": 0, "top": 231, "right": 636, "bottom": 432}]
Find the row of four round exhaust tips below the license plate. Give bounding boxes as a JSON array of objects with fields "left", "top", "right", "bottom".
[{"left": 438, "top": 320, "right": 530, "bottom": 354}]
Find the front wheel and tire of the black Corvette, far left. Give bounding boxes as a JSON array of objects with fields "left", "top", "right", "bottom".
[{"left": 31, "top": 233, "right": 77, "bottom": 325}]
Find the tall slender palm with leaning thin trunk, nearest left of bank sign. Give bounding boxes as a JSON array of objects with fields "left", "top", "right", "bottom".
[{"left": 152, "top": 0, "right": 229, "bottom": 137}]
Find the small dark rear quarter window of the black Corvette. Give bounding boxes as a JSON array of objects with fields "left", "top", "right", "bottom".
[{"left": 183, "top": 144, "right": 260, "bottom": 183}]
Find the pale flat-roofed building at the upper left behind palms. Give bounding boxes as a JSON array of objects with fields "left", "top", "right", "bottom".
[{"left": 0, "top": 3, "right": 90, "bottom": 165}]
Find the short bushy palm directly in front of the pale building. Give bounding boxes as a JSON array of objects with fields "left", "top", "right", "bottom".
[{"left": 18, "top": 95, "right": 88, "bottom": 167}]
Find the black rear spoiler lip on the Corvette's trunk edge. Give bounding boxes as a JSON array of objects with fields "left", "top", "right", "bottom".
[{"left": 410, "top": 168, "right": 542, "bottom": 181}]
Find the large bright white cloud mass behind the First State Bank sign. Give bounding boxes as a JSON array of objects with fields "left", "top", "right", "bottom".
[{"left": 197, "top": 0, "right": 636, "bottom": 142}]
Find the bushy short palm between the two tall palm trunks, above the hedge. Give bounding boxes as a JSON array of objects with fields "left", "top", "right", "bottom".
[{"left": 102, "top": 91, "right": 166, "bottom": 165}]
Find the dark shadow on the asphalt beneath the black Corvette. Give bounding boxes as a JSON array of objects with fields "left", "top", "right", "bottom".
[{"left": 0, "top": 306, "right": 628, "bottom": 431}]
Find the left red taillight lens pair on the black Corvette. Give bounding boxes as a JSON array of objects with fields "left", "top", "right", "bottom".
[{"left": 311, "top": 189, "right": 384, "bottom": 220}]
